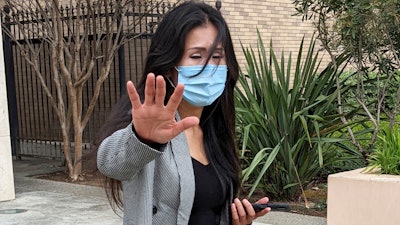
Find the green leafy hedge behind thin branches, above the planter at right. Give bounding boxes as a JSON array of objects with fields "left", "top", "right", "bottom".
[{"left": 334, "top": 70, "right": 400, "bottom": 156}]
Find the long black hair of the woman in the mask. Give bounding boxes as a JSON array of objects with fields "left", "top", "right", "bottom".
[{"left": 94, "top": 1, "right": 240, "bottom": 209}]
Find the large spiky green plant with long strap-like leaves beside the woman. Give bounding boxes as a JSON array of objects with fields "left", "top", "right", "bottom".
[{"left": 235, "top": 33, "right": 360, "bottom": 199}]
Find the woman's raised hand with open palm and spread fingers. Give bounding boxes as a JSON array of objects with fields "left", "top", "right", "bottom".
[{"left": 126, "top": 73, "right": 199, "bottom": 144}]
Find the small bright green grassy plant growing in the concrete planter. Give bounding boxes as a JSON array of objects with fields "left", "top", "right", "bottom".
[{"left": 365, "top": 126, "right": 400, "bottom": 175}]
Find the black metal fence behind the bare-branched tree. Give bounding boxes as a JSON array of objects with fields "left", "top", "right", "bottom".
[{"left": 2, "top": 1, "right": 173, "bottom": 159}]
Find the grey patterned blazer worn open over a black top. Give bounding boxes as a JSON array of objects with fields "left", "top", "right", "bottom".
[{"left": 97, "top": 124, "right": 233, "bottom": 225}]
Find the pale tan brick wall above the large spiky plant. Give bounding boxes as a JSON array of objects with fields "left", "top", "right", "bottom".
[{"left": 206, "top": 0, "right": 328, "bottom": 69}]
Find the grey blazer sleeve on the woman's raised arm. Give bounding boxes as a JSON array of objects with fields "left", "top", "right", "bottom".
[{"left": 97, "top": 124, "right": 165, "bottom": 181}]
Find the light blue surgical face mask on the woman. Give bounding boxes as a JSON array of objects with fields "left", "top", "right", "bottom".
[{"left": 176, "top": 64, "right": 228, "bottom": 107}]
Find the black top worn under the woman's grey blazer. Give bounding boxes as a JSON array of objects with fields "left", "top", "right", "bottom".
[{"left": 189, "top": 158, "right": 226, "bottom": 225}]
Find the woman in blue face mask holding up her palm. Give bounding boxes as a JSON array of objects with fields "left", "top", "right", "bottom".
[{"left": 97, "top": 1, "right": 270, "bottom": 225}]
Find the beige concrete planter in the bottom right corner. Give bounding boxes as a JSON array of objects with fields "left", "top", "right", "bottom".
[{"left": 327, "top": 169, "right": 400, "bottom": 225}]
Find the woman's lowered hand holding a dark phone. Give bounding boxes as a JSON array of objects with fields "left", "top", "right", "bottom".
[{"left": 231, "top": 197, "right": 271, "bottom": 225}]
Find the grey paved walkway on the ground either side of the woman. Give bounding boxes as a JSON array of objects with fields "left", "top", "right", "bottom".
[{"left": 0, "top": 158, "right": 326, "bottom": 225}]
